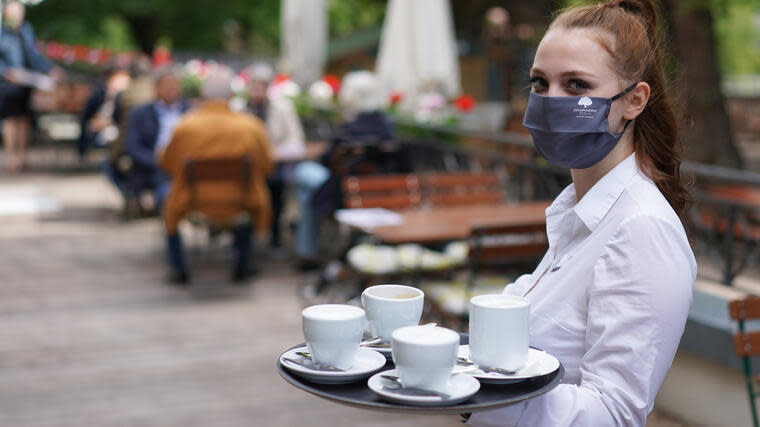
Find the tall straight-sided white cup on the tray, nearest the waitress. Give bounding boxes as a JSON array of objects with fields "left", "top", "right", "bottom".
[{"left": 470, "top": 294, "right": 530, "bottom": 371}]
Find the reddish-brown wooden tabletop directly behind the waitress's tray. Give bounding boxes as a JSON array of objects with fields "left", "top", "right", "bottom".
[{"left": 361, "top": 201, "right": 551, "bottom": 245}]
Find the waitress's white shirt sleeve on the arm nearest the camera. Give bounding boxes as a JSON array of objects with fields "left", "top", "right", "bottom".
[{"left": 469, "top": 215, "right": 696, "bottom": 427}]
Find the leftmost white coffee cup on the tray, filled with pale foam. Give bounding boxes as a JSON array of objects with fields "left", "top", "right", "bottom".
[{"left": 301, "top": 304, "right": 364, "bottom": 370}]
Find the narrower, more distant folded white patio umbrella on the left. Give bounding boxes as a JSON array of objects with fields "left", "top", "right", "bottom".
[{"left": 280, "top": 0, "right": 327, "bottom": 87}]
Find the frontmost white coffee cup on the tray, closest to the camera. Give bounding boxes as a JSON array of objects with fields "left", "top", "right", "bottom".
[{"left": 391, "top": 326, "right": 459, "bottom": 391}]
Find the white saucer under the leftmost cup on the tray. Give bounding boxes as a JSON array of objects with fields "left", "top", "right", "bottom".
[{"left": 280, "top": 345, "right": 386, "bottom": 384}]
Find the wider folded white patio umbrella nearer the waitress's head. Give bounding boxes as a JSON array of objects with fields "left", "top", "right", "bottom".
[{"left": 376, "top": 0, "right": 461, "bottom": 106}]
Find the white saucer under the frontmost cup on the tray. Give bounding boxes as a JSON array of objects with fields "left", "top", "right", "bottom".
[{"left": 367, "top": 369, "right": 480, "bottom": 406}]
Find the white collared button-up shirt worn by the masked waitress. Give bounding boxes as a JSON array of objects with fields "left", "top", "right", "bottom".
[{"left": 469, "top": 155, "right": 697, "bottom": 427}]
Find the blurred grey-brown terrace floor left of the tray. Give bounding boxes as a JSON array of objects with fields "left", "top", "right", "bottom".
[{"left": 0, "top": 159, "right": 682, "bottom": 427}]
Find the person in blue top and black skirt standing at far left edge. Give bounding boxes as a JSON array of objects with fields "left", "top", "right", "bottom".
[{"left": 0, "top": 1, "right": 62, "bottom": 173}]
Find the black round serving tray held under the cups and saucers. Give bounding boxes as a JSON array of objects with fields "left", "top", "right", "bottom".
[{"left": 277, "top": 335, "right": 565, "bottom": 415}]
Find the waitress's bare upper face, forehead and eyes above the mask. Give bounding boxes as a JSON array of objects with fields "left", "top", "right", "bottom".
[{"left": 530, "top": 28, "right": 625, "bottom": 132}]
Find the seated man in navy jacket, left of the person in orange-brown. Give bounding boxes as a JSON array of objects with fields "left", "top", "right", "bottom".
[{"left": 125, "top": 69, "right": 189, "bottom": 211}]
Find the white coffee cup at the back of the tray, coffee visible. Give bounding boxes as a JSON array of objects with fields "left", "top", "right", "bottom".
[{"left": 362, "top": 285, "right": 425, "bottom": 342}]
